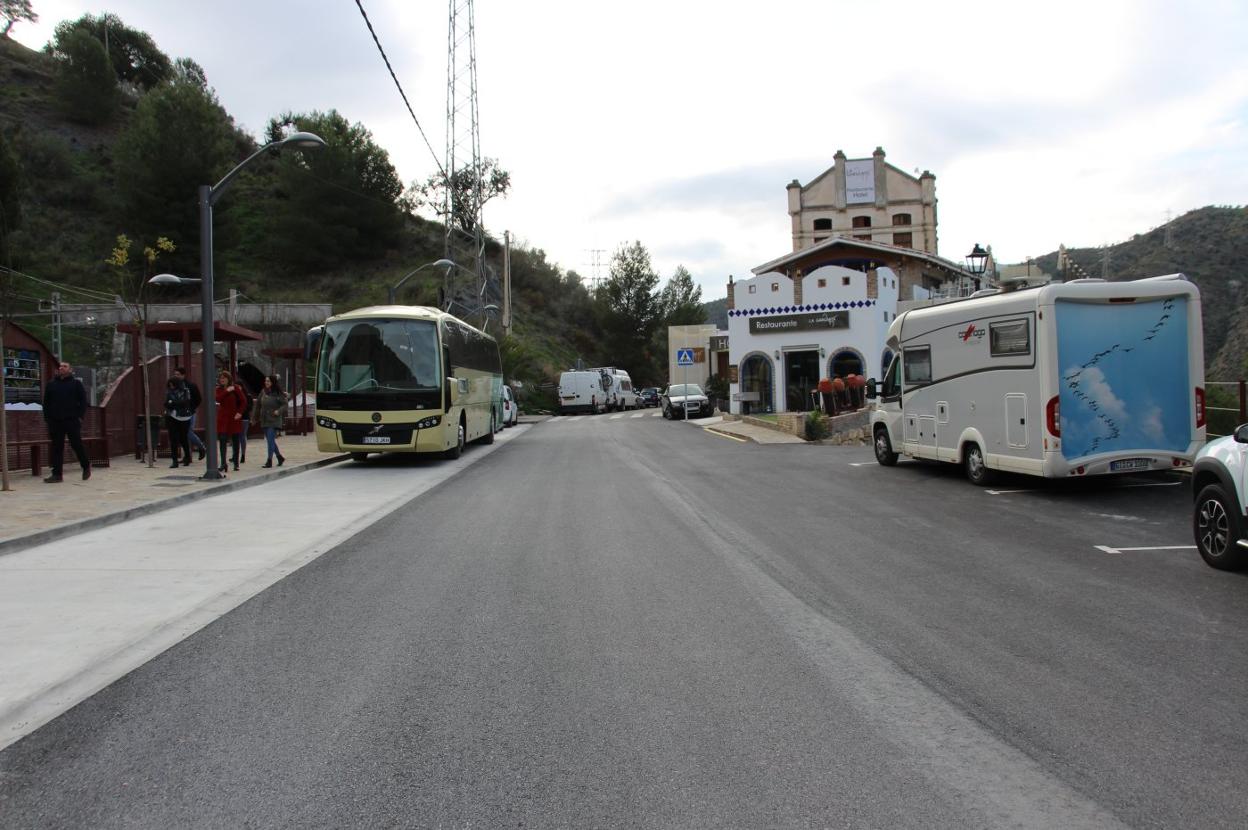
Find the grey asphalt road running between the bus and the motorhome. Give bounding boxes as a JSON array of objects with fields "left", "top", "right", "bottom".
[{"left": 0, "top": 416, "right": 1248, "bottom": 828}]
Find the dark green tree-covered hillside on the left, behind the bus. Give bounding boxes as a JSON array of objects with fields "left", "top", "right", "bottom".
[{"left": 0, "top": 14, "right": 703, "bottom": 406}]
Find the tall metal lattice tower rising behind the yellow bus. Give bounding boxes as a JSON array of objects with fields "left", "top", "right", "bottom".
[{"left": 443, "top": 0, "right": 488, "bottom": 315}]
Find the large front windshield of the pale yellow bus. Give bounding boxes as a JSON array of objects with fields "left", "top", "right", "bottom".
[{"left": 317, "top": 320, "right": 442, "bottom": 394}]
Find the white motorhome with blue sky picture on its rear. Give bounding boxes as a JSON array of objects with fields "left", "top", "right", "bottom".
[{"left": 867, "top": 275, "right": 1204, "bottom": 484}]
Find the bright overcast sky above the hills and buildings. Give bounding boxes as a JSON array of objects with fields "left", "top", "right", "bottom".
[{"left": 14, "top": 0, "right": 1248, "bottom": 300}]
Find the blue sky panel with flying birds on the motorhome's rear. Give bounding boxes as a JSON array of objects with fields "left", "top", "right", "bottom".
[{"left": 1057, "top": 298, "right": 1191, "bottom": 458}]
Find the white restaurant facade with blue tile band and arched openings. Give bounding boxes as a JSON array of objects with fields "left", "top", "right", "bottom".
[{"left": 728, "top": 265, "right": 899, "bottom": 414}]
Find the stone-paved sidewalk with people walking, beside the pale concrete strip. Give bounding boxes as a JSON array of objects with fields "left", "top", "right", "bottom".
[{"left": 0, "top": 433, "right": 338, "bottom": 555}]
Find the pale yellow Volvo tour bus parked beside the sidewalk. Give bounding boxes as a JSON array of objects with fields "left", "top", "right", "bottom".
[{"left": 307, "top": 306, "right": 503, "bottom": 461}]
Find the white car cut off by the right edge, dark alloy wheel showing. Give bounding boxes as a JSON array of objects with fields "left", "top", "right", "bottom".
[{"left": 1192, "top": 423, "right": 1248, "bottom": 570}]
